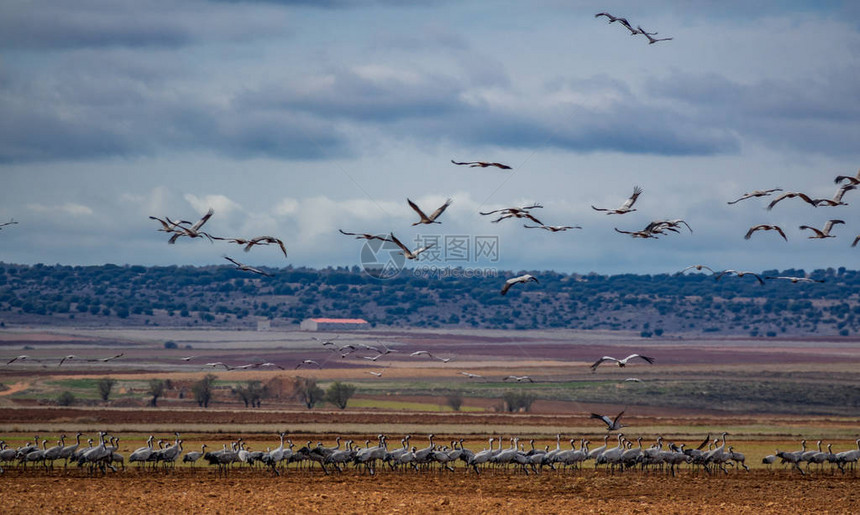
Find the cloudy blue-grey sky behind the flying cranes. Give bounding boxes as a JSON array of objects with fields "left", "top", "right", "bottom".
[{"left": 0, "top": 0, "right": 860, "bottom": 273}]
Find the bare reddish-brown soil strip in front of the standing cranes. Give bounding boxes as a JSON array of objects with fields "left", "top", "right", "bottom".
[{"left": 0, "top": 469, "right": 860, "bottom": 514}]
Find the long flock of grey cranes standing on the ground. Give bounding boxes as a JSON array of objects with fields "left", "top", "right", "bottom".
[{"left": 0, "top": 432, "right": 860, "bottom": 476}]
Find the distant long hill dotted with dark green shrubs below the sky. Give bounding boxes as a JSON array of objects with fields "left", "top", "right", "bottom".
[{"left": 0, "top": 263, "right": 860, "bottom": 337}]
